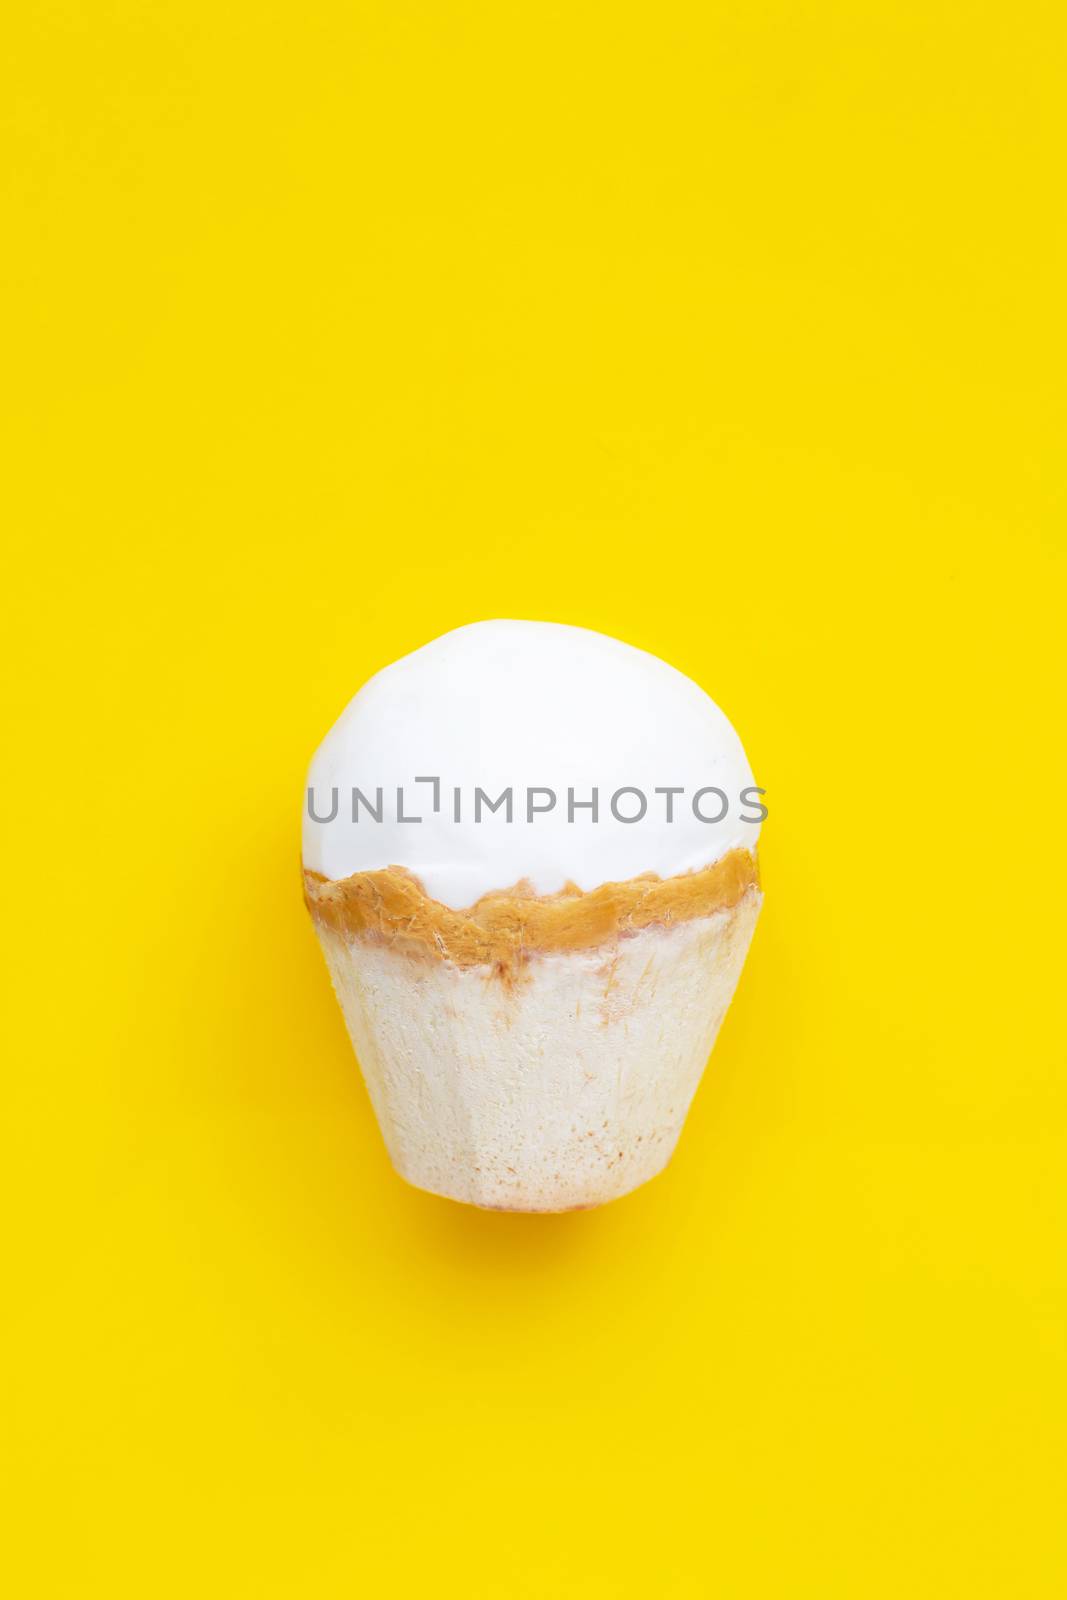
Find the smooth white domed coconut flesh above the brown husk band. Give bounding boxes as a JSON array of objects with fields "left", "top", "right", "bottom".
[{"left": 304, "top": 622, "right": 760, "bottom": 907}]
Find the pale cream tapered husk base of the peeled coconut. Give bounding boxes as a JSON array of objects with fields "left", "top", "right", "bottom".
[{"left": 315, "top": 888, "right": 761, "bottom": 1211}]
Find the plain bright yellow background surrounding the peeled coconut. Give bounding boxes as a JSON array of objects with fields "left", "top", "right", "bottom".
[{"left": 2, "top": 0, "right": 1067, "bottom": 1600}]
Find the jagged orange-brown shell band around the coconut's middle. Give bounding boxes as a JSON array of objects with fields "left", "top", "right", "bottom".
[{"left": 304, "top": 850, "right": 760, "bottom": 974}]
